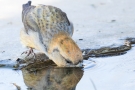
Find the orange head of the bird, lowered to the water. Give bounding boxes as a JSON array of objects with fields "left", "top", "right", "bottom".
[{"left": 48, "top": 33, "right": 83, "bottom": 65}]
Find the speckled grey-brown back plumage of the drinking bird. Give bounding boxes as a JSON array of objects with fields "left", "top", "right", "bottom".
[{"left": 22, "top": 5, "right": 73, "bottom": 44}]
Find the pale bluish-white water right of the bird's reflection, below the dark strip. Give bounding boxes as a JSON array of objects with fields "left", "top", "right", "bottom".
[{"left": 77, "top": 48, "right": 135, "bottom": 90}]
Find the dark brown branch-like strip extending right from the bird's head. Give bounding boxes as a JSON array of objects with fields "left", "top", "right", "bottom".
[{"left": 82, "top": 38, "right": 135, "bottom": 60}]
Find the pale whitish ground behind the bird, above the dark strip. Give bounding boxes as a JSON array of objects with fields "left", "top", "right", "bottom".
[{"left": 0, "top": 0, "right": 135, "bottom": 58}]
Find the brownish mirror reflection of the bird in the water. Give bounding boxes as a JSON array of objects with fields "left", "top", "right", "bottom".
[{"left": 22, "top": 62, "right": 83, "bottom": 90}]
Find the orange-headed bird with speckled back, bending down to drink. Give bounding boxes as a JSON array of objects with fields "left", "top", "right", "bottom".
[{"left": 20, "top": 1, "right": 83, "bottom": 67}]
